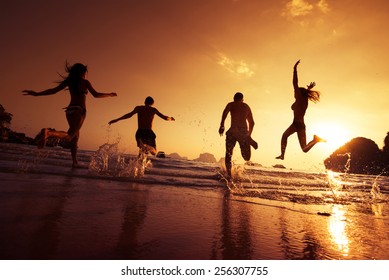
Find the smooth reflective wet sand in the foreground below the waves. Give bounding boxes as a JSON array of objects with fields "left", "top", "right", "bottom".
[{"left": 0, "top": 169, "right": 389, "bottom": 260}]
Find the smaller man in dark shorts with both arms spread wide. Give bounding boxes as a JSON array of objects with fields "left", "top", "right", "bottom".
[{"left": 108, "top": 96, "right": 175, "bottom": 155}]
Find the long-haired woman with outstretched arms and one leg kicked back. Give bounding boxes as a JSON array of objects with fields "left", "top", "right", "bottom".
[{"left": 23, "top": 63, "right": 116, "bottom": 167}]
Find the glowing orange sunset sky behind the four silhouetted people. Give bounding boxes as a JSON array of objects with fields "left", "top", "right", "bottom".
[{"left": 0, "top": 0, "right": 389, "bottom": 171}]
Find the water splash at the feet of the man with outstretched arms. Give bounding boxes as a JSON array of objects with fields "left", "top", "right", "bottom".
[{"left": 88, "top": 143, "right": 151, "bottom": 178}]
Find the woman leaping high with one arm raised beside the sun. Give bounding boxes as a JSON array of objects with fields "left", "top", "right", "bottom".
[{"left": 276, "top": 60, "right": 326, "bottom": 160}]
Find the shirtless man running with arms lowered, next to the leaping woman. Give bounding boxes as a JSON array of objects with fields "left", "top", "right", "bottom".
[{"left": 219, "top": 92, "right": 258, "bottom": 177}]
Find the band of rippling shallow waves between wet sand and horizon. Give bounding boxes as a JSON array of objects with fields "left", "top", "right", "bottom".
[{"left": 0, "top": 143, "right": 389, "bottom": 204}]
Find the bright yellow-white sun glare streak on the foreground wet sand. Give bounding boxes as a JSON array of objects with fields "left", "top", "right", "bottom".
[{"left": 329, "top": 205, "right": 349, "bottom": 256}]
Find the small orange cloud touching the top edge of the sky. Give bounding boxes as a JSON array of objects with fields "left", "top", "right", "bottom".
[{"left": 282, "top": 0, "right": 330, "bottom": 18}]
